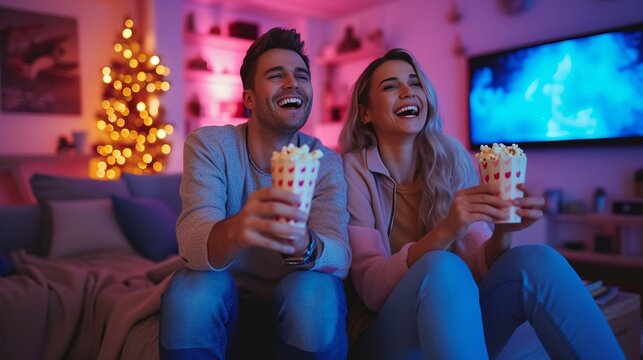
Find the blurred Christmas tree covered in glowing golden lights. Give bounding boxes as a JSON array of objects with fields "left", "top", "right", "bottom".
[{"left": 95, "top": 19, "right": 174, "bottom": 179}]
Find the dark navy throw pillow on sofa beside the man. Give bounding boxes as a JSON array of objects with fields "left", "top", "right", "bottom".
[{"left": 111, "top": 195, "right": 178, "bottom": 261}]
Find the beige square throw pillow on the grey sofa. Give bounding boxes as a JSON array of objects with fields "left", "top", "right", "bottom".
[{"left": 49, "top": 199, "right": 134, "bottom": 258}]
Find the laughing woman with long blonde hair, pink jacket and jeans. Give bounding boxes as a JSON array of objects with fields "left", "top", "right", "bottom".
[{"left": 340, "top": 49, "right": 623, "bottom": 359}]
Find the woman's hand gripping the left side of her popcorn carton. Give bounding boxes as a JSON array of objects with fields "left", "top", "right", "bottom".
[{"left": 439, "top": 184, "right": 510, "bottom": 242}]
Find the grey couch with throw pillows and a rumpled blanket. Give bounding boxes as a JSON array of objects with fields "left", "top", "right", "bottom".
[{"left": 0, "top": 174, "right": 547, "bottom": 360}]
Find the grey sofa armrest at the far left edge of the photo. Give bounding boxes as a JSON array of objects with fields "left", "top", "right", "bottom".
[{"left": 0, "top": 204, "right": 40, "bottom": 254}]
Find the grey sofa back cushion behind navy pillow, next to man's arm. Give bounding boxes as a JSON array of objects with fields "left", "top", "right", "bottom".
[{"left": 123, "top": 173, "right": 182, "bottom": 216}]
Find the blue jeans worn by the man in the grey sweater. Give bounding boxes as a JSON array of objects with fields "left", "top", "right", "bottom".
[{"left": 159, "top": 269, "right": 348, "bottom": 359}]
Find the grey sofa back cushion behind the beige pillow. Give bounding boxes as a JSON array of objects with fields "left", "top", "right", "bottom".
[{"left": 30, "top": 173, "right": 129, "bottom": 256}]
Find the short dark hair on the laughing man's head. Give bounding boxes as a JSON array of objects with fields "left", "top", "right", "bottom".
[{"left": 241, "top": 28, "right": 310, "bottom": 89}]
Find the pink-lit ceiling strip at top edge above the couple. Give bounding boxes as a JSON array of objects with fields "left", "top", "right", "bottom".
[{"left": 211, "top": 0, "right": 395, "bottom": 18}]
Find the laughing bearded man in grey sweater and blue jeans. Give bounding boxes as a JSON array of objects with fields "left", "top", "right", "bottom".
[{"left": 160, "top": 28, "right": 350, "bottom": 359}]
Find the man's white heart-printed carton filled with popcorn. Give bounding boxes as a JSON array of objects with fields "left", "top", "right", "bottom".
[{"left": 270, "top": 144, "right": 324, "bottom": 238}]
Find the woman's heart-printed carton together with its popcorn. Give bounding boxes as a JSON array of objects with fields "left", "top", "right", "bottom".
[{"left": 475, "top": 143, "right": 527, "bottom": 223}]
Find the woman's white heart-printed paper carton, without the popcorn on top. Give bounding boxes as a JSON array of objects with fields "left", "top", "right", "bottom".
[{"left": 478, "top": 156, "right": 527, "bottom": 223}]
